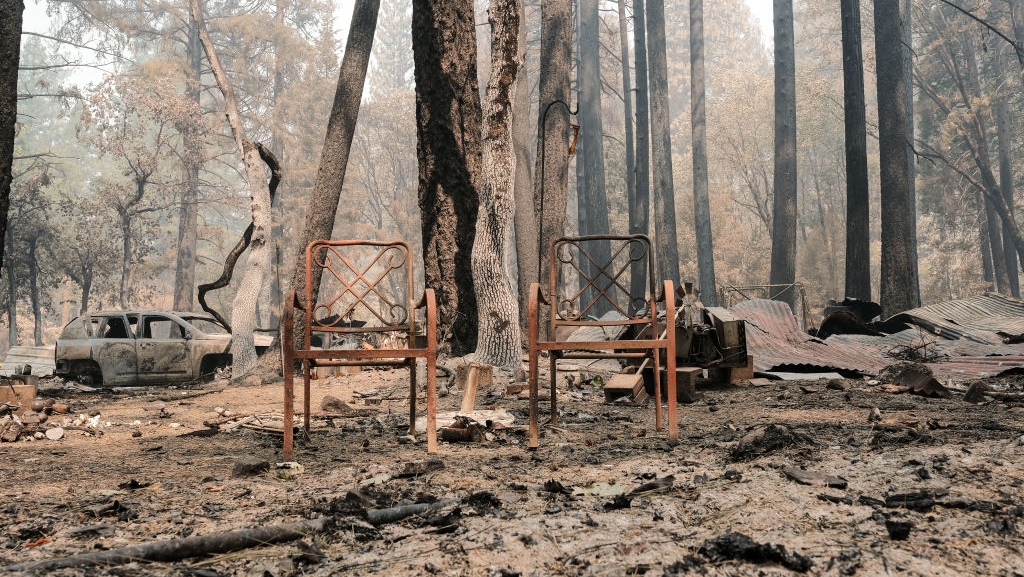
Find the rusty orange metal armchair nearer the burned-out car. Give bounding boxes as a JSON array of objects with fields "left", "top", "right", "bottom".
[{"left": 281, "top": 240, "right": 437, "bottom": 460}]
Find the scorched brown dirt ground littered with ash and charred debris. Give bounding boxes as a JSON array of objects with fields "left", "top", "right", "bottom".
[{"left": 0, "top": 366, "right": 1024, "bottom": 577}]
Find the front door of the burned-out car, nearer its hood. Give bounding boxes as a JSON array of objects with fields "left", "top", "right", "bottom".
[{"left": 137, "top": 315, "right": 193, "bottom": 384}]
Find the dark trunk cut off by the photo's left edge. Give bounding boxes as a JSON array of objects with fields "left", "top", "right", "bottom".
[{"left": 0, "top": 0, "right": 25, "bottom": 270}]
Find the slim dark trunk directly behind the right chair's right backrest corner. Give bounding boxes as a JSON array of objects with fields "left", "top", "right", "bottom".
[{"left": 630, "top": 0, "right": 659, "bottom": 294}]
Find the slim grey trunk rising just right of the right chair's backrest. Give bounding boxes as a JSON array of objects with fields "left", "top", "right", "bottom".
[{"left": 647, "top": 0, "right": 679, "bottom": 282}]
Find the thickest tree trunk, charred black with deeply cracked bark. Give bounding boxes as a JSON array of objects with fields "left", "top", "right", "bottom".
[{"left": 413, "top": 0, "right": 482, "bottom": 356}]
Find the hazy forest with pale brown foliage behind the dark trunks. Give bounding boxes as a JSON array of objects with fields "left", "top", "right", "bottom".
[{"left": 6, "top": 0, "right": 1024, "bottom": 354}]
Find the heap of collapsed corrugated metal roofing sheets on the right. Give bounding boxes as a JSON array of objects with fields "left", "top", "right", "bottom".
[{"left": 729, "top": 294, "right": 1024, "bottom": 380}]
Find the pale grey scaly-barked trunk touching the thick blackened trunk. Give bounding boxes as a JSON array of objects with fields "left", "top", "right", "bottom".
[{"left": 473, "top": 0, "right": 522, "bottom": 369}]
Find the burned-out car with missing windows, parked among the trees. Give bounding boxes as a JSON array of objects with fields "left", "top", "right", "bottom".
[{"left": 54, "top": 311, "right": 260, "bottom": 386}]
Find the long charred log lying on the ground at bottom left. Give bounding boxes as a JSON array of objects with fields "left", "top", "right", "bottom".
[{"left": 2, "top": 518, "right": 334, "bottom": 572}]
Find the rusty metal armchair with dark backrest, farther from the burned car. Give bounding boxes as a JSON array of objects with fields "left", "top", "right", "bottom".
[{"left": 528, "top": 235, "right": 679, "bottom": 448}]
